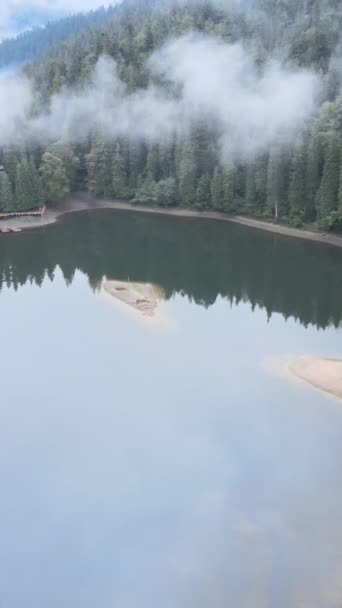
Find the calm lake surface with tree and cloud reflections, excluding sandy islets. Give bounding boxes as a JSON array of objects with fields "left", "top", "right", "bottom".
[{"left": 0, "top": 211, "right": 342, "bottom": 608}]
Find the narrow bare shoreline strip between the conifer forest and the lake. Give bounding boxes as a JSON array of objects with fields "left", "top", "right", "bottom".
[{"left": 0, "top": 198, "right": 342, "bottom": 247}]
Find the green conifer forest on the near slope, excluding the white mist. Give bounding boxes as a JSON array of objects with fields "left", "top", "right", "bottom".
[{"left": 0, "top": 0, "right": 342, "bottom": 230}]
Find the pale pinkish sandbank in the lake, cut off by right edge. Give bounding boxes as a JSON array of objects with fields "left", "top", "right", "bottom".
[{"left": 288, "top": 356, "right": 342, "bottom": 399}]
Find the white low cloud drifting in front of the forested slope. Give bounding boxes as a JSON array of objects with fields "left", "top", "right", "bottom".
[{"left": 0, "top": 34, "right": 320, "bottom": 159}]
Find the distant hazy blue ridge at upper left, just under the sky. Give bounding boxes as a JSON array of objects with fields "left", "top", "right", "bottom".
[{"left": 0, "top": 7, "right": 121, "bottom": 68}]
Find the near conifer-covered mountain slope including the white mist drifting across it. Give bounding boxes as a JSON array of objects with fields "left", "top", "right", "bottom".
[{"left": 0, "top": 0, "right": 342, "bottom": 230}]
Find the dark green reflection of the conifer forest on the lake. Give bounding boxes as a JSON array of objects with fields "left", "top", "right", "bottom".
[{"left": 0, "top": 210, "right": 342, "bottom": 328}]
